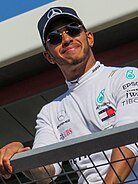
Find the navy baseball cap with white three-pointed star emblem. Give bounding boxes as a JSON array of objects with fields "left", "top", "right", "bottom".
[{"left": 38, "top": 7, "right": 83, "bottom": 46}]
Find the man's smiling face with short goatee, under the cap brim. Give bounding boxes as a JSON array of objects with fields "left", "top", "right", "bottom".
[{"left": 44, "top": 18, "right": 93, "bottom": 67}]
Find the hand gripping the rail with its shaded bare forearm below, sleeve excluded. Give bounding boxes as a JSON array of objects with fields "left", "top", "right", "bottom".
[{"left": 0, "top": 142, "right": 55, "bottom": 184}]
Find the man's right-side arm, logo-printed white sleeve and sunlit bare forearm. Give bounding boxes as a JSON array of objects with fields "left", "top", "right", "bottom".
[{"left": 105, "top": 67, "right": 138, "bottom": 184}]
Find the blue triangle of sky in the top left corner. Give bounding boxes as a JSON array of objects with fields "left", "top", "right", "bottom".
[{"left": 0, "top": 0, "right": 54, "bottom": 22}]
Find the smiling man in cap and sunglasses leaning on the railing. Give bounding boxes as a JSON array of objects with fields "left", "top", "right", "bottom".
[{"left": 0, "top": 7, "right": 138, "bottom": 184}]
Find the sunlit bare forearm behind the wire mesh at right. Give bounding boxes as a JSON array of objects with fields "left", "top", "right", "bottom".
[{"left": 105, "top": 146, "right": 136, "bottom": 184}]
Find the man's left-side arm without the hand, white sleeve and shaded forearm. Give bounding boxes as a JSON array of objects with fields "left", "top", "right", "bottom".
[{"left": 24, "top": 106, "right": 61, "bottom": 184}]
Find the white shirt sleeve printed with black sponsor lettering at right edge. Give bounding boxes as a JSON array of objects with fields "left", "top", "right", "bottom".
[{"left": 112, "top": 67, "right": 138, "bottom": 155}]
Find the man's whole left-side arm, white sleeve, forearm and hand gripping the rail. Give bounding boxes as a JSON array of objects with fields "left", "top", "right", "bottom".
[{"left": 0, "top": 106, "right": 61, "bottom": 181}]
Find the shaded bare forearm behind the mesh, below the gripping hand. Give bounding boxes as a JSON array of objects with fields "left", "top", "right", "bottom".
[{"left": 23, "top": 164, "right": 55, "bottom": 184}]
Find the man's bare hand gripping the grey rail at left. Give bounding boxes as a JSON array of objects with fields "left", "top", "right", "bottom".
[{"left": 0, "top": 142, "right": 31, "bottom": 179}]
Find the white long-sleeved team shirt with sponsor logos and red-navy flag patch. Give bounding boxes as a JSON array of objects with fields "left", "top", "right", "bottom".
[{"left": 33, "top": 61, "right": 138, "bottom": 184}]
